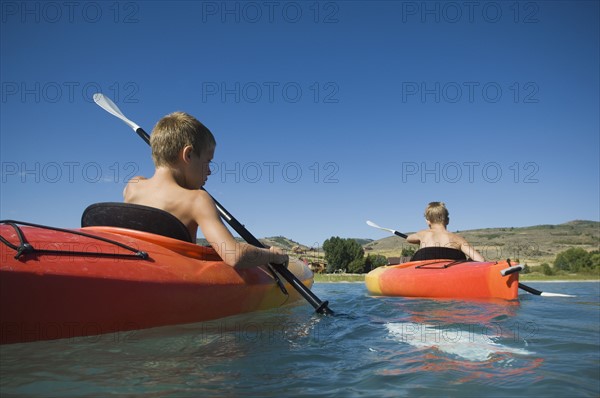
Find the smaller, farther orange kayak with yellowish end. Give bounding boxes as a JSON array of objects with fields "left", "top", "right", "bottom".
[{"left": 365, "top": 260, "right": 519, "bottom": 300}]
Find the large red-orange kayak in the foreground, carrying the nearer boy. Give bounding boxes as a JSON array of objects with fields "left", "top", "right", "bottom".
[{"left": 0, "top": 225, "right": 313, "bottom": 344}]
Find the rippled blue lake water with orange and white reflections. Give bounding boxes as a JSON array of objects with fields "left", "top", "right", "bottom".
[{"left": 0, "top": 282, "right": 600, "bottom": 397}]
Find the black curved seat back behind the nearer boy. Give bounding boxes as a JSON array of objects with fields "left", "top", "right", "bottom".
[{"left": 81, "top": 202, "right": 196, "bottom": 243}]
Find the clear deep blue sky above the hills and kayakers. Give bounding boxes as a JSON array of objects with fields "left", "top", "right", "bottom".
[{"left": 0, "top": 1, "right": 600, "bottom": 245}]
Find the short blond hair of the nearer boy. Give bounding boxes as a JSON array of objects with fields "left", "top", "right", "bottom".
[{"left": 150, "top": 112, "right": 217, "bottom": 167}]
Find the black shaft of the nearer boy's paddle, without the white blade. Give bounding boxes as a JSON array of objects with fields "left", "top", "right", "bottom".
[{"left": 135, "top": 127, "right": 333, "bottom": 315}]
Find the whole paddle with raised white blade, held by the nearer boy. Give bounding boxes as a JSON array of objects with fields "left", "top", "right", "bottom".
[{"left": 94, "top": 93, "right": 333, "bottom": 315}]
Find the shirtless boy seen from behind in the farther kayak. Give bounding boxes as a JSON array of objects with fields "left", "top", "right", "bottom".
[{"left": 406, "top": 202, "right": 485, "bottom": 261}]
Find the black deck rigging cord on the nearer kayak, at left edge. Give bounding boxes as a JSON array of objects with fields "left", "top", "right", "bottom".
[{"left": 0, "top": 220, "right": 148, "bottom": 260}]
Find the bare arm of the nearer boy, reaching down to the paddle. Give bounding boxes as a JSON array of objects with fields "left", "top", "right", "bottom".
[{"left": 193, "top": 191, "right": 289, "bottom": 269}]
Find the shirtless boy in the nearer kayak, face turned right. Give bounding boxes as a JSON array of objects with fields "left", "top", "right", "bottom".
[{"left": 123, "top": 112, "right": 288, "bottom": 269}]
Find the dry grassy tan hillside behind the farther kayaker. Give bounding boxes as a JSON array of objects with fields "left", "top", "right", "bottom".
[{"left": 364, "top": 220, "right": 600, "bottom": 265}]
